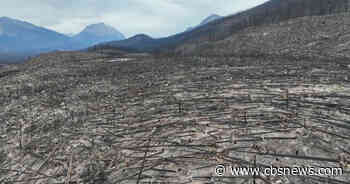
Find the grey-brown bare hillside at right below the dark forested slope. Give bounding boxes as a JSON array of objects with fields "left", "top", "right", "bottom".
[{"left": 177, "top": 13, "right": 350, "bottom": 58}]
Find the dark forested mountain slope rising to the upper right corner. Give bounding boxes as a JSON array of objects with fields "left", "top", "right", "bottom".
[{"left": 95, "top": 0, "right": 350, "bottom": 52}]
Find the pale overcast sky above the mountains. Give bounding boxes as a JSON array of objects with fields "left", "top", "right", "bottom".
[{"left": 0, "top": 0, "right": 267, "bottom": 37}]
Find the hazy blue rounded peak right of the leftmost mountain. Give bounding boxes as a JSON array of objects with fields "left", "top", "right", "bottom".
[{"left": 73, "top": 23, "right": 125, "bottom": 47}]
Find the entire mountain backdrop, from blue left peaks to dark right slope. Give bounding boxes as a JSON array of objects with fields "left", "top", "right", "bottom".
[{"left": 0, "top": 0, "right": 350, "bottom": 62}]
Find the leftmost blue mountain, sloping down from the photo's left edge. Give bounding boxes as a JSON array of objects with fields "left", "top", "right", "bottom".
[{"left": 0, "top": 17, "right": 74, "bottom": 55}]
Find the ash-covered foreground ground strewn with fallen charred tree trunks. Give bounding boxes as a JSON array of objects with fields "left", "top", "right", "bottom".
[{"left": 0, "top": 52, "right": 350, "bottom": 184}]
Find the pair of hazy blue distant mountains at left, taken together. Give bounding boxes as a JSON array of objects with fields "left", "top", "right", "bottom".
[{"left": 0, "top": 17, "right": 125, "bottom": 63}]
